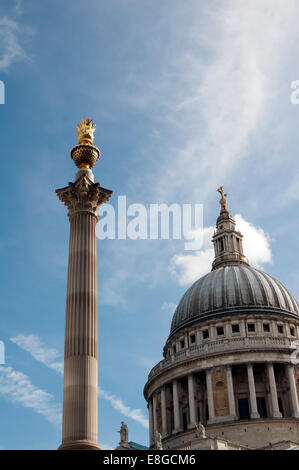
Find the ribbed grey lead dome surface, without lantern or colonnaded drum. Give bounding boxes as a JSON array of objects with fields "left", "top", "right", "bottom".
[{"left": 170, "top": 266, "right": 299, "bottom": 335}]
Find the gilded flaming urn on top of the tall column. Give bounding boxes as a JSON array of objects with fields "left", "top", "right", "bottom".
[{"left": 71, "top": 118, "right": 101, "bottom": 170}]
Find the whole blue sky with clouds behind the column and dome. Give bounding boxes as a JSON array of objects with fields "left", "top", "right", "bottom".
[{"left": 0, "top": 0, "right": 299, "bottom": 449}]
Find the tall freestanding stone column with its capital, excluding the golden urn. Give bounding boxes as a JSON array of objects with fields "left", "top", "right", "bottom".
[{"left": 56, "top": 170, "right": 111, "bottom": 449}]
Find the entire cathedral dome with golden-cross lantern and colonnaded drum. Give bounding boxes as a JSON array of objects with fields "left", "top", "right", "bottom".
[{"left": 144, "top": 187, "right": 299, "bottom": 449}]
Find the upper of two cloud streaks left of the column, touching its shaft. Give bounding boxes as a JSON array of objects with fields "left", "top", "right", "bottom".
[{"left": 10, "top": 334, "right": 63, "bottom": 374}]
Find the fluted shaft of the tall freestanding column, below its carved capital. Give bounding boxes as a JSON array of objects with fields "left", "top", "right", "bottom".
[{"left": 62, "top": 212, "right": 98, "bottom": 445}]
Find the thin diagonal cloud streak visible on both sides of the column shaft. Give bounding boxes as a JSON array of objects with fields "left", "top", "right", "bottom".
[{"left": 10, "top": 334, "right": 148, "bottom": 427}]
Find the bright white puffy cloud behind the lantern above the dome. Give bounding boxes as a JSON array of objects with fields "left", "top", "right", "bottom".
[{"left": 169, "top": 214, "right": 272, "bottom": 285}]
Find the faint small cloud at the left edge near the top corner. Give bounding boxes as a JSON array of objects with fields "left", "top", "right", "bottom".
[{"left": 0, "top": 17, "right": 26, "bottom": 71}]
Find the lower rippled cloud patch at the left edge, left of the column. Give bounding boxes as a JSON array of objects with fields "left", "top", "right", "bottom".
[{"left": 0, "top": 366, "right": 61, "bottom": 425}]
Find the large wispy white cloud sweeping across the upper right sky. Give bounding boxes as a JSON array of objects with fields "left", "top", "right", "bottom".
[{"left": 124, "top": 0, "right": 298, "bottom": 204}]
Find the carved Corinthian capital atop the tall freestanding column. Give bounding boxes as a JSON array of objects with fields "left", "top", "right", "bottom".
[{"left": 56, "top": 174, "right": 112, "bottom": 219}]
